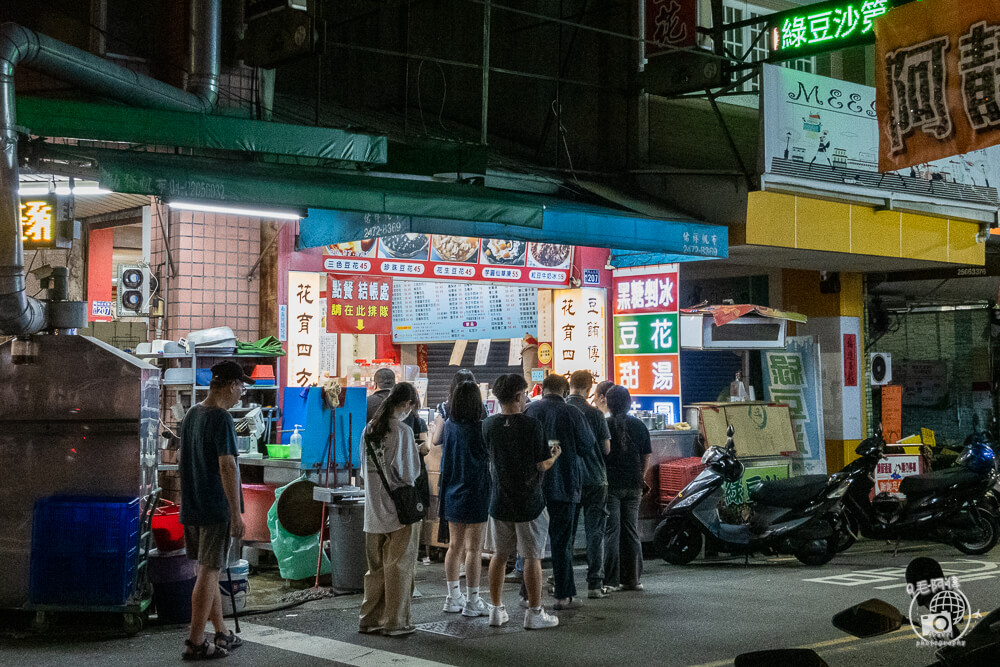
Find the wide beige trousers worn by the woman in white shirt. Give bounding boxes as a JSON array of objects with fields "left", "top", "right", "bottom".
[{"left": 360, "top": 522, "right": 420, "bottom": 630}]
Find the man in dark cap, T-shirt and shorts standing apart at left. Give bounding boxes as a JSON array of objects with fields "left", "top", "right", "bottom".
[{"left": 178, "top": 361, "right": 254, "bottom": 660}]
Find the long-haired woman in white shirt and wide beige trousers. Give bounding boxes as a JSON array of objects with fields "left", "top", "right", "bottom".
[{"left": 358, "top": 382, "right": 420, "bottom": 637}]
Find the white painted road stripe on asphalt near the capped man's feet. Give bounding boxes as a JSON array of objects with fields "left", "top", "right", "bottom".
[{"left": 240, "top": 623, "right": 449, "bottom": 667}]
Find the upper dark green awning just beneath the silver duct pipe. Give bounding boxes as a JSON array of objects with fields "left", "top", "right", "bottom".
[{"left": 17, "top": 95, "right": 387, "bottom": 164}]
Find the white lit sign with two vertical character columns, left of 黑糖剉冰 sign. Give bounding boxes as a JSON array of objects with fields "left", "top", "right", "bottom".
[{"left": 552, "top": 287, "right": 608, "bottom": 381}]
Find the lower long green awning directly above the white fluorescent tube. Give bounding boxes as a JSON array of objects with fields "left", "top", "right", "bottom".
[{"left": 90, "top": 146, "right": 544, "bottom": 227}]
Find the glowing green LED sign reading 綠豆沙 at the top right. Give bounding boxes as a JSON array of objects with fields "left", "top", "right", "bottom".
[{"left": 765, "top": 0, "right": 911, "bottom": 61}]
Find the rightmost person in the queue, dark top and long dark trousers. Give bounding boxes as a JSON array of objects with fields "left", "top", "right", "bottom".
[{"left": 604, "top": 385, "right": 652, "bottom": 591}]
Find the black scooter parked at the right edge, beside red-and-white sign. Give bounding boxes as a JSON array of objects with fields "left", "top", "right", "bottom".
[{"left": 837, "top": 433, "right": 1000, "bottom": 555}]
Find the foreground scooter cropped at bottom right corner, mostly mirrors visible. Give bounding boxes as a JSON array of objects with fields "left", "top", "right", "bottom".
[{"left": 733, "top": 558, "right": 1000, "bottom": 667}]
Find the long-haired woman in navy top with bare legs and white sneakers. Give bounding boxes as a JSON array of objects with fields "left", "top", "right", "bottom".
[{"left": 438, "top": 382, "right": 490, "bottom": 617}]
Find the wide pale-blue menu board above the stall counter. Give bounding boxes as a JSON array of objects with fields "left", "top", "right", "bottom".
[{"left": 392, "top": 280, "right": 538, "bottom": 343}]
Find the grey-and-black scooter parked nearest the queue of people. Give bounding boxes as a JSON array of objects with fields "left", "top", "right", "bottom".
[{"left": 653, "top": 426, "right": 850, "bottom": 566}]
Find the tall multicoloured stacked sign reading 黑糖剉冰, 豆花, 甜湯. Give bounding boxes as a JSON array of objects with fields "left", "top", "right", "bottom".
[{"left": 610, "top": 266, "right": 681, "bottom": 424}]
